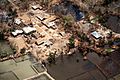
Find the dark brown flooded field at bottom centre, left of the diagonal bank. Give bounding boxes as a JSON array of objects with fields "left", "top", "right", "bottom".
[{"left": 47, "top": 53, "right": 106, "bottom": 80}]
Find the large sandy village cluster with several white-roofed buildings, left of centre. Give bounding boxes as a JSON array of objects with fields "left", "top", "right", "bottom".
[{"left": 8, "top": 5, "right": 70, "bottom": 60}]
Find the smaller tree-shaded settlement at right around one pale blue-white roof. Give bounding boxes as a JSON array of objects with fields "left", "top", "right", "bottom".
[{"left": 74, "top": 16, "right": 120, "bottom": 56}]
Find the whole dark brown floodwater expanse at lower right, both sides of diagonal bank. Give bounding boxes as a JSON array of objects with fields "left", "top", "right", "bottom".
[{"left": 47, "top": 51, "right": 120, "bottom": 80}]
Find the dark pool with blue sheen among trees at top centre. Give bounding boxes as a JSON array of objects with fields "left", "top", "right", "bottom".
[{"left": 53, "top": 1, "right": 84, "bottom": 21}]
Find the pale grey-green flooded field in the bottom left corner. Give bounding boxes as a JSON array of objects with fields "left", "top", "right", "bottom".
[{"left": 0, "top": 55, "right": 45, "bottom": 80}]
